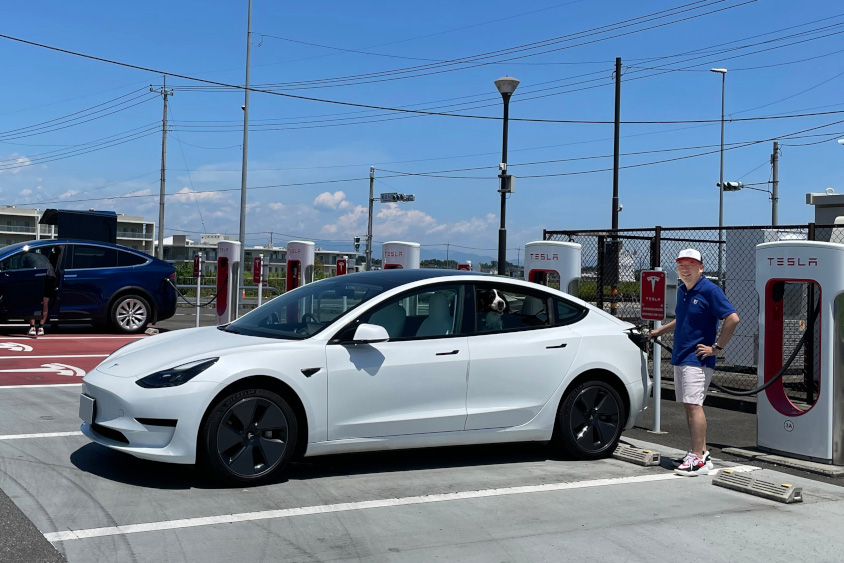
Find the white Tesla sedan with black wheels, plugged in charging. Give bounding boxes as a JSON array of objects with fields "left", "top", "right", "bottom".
[{"left": 79, "top": 270, "right": 651, "bottom": 484}]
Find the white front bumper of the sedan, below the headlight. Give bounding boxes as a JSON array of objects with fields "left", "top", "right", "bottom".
[{"left": 81, "top": 369, "right": 217, "bottom": 464}]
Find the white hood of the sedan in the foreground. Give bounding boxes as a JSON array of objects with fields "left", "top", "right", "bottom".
[{"left": 96, "top": 327, "right": 302, "bottom": 377}]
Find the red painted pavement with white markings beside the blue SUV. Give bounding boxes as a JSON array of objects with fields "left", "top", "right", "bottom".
[{"left": 0, "top": 334, "right": 145, "bottom": 387}]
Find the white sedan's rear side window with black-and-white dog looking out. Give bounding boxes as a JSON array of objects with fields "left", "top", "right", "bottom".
[{"left": 475, "top": 285, "right": 551, "bottom": 333}]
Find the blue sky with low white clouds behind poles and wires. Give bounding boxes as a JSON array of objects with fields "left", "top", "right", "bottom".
[{"left": 0, "top": 0, "right": 844, "bottom": 258}]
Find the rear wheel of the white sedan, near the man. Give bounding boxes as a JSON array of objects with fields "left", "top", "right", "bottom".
[{"left": 553, "top": 380, "right": 627, "bottom": 459}]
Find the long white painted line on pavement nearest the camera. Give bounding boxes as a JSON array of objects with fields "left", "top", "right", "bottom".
[{"left": 44, "top": 473, "right": 682, "bottom": 542}]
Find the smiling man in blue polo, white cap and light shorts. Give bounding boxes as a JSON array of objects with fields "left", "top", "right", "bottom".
[{"left": 651, "top": 248, "right": 739, "bottom": 476}]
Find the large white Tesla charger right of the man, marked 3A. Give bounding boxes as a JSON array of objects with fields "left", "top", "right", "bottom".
[{"left": 756, "top": 241, "right": 844, "bottom": 465}]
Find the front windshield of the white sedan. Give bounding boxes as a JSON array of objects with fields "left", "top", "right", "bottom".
[{"left": 220, "top": 276, "right": 390, "bottom": 340}]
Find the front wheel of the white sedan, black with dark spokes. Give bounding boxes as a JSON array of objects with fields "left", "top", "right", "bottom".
[{"left": 199, "top": 389, "right": 298, "bottom": 485}]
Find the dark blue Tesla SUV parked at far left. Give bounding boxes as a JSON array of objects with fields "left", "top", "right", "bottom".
[{"left": 0, "top": 240, "right": 176, "bottom": 334}]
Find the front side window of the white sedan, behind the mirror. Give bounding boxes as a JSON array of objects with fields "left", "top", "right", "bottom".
[{"left": 361, "top": 285, "right": 463, "bottom": 340}]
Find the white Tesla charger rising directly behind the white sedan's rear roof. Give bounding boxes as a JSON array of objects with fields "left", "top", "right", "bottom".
[{"left": 525, "top": 240, "right": 581, "bottom": 296}]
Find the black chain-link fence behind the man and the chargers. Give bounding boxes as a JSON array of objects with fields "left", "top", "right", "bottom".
[{"left": 543, "top": 223, "right": 844, "bottom": 398}]
